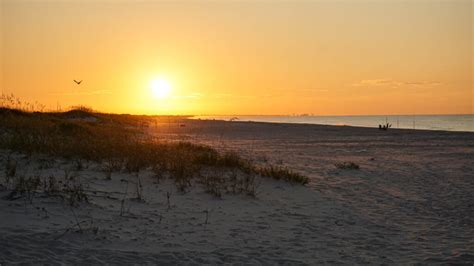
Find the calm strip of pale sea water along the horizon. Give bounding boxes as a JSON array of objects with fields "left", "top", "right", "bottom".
[{"left": 195, "top": 115, "right": 474, "bottom": 132}]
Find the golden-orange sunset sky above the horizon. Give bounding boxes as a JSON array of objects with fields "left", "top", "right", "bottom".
[{"left": 0, "top": 0, "right": 474, "bottom": 115}]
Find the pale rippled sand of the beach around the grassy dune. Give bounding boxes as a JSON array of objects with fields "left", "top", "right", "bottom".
[{"left": 0, "top": 121, "right": 474, "bottom": 264}]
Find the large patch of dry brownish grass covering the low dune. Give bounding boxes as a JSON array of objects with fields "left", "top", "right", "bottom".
[{"left": 0, "top": 102, "right": 308, "bottom": 197}]
